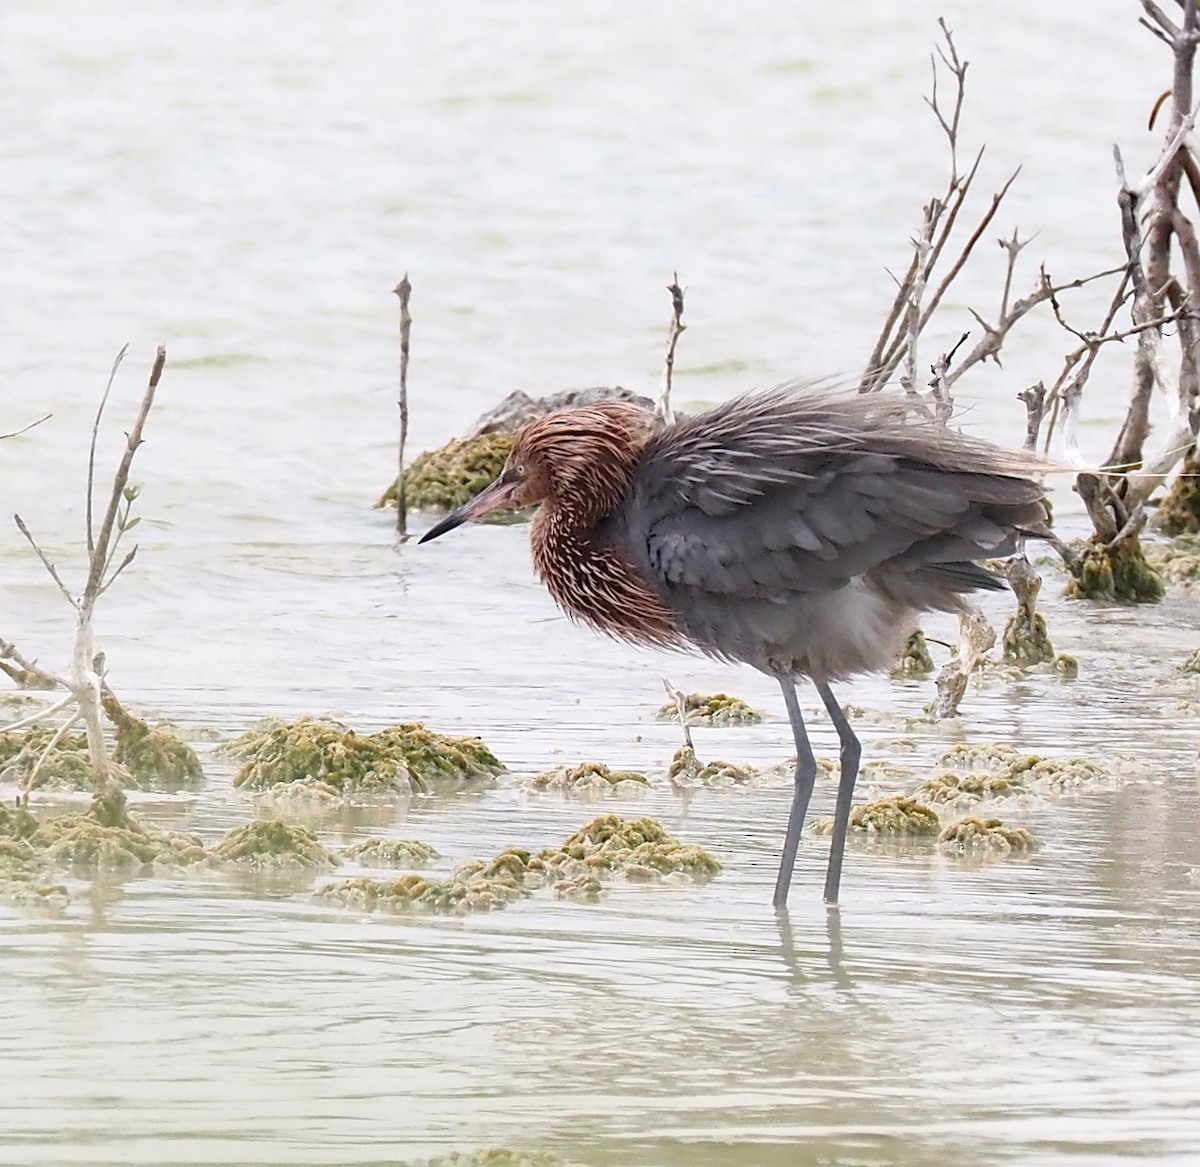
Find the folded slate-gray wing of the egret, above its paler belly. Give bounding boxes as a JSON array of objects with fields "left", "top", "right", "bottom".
[{"left": 626, "top": 389, "right": 1043, "bottom": 598}]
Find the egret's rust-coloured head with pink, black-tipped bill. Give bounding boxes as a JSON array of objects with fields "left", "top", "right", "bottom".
[{"left": 420, "top": 401, "right": 653, "bottom": 543}]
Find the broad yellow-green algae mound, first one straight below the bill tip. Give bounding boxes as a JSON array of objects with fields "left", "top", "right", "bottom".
[{"left": 221, "top": 717, "right": 504, "bottom": 797}]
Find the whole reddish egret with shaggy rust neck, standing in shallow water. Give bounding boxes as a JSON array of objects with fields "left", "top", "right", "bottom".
[{"left": 421, "top": 385, "right": 1045, "bottom": 908}]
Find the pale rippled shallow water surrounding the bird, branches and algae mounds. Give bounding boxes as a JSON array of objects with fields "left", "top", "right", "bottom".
[{"left": 0, "top": 0, "right": 1200, "bottom": 1165}]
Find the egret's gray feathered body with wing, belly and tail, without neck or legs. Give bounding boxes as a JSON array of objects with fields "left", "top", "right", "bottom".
[{"left": 620, "top": 387, "right": 1044, "bottom": 680}]
